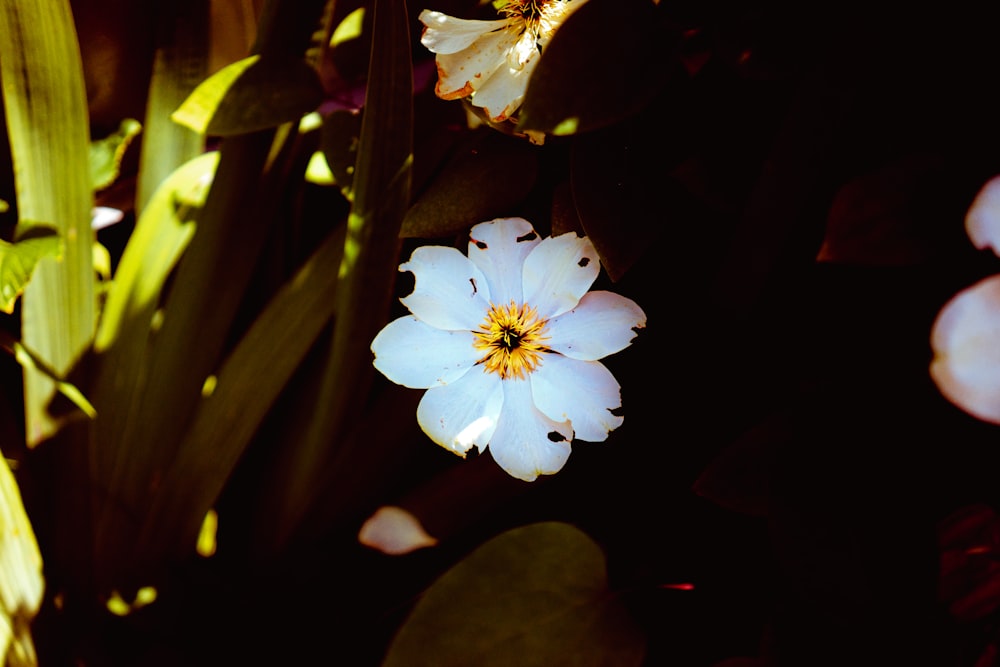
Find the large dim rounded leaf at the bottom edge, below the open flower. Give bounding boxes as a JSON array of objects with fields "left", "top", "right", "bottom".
[{"left": 382, "top": 522, "right": 645, "bottom": 667}]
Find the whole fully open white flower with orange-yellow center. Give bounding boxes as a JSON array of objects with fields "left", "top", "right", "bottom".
[{"left": 372, "top": 218, "right": 646, "bottom": 481}]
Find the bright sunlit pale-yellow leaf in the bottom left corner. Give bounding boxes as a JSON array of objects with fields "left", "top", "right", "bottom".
[{"left": 0, "top": 453, "right": 45, "bottom": 665}]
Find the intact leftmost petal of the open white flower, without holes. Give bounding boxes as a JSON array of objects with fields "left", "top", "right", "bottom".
[{"left": 372, "top": 316, "right": 481, "bottom": 389}]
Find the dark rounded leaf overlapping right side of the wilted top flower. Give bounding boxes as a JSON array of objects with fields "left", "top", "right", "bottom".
[{"left": 518, "top": 0, "right": 679, "bottom": 135}]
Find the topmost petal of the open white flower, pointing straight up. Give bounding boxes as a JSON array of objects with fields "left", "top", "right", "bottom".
[{"left": 469, "top": 218, "right": 540, "bottom": 306}]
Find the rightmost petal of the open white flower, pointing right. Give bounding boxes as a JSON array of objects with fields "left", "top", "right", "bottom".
[{"left": 546, "top": 291, "right": 646, "bottom": 361}]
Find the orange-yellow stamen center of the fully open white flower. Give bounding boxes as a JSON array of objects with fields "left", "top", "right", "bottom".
[{"left": 473, "top": 301, "right": 549, "bottom": 380}]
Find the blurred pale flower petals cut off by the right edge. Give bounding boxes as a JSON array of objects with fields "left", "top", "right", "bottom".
[{"left": 931, "top": 176, "right": 1000, "bottom": 424}]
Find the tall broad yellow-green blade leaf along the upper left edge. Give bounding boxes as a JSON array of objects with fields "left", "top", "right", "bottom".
[{"left": 0, "top": 0, "right": 97, "bottom": 446}]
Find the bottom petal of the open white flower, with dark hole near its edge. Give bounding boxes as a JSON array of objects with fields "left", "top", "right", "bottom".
[{"left": 489, "top": 380, "right": 573, "bottom": 482}]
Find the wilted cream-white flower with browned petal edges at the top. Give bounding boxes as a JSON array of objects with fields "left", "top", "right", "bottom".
[{"left": 420, "top": 0, "right": 587, "bottom": 123}]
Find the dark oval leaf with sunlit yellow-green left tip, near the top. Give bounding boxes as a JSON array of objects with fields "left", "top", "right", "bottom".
[{"left": 171, "top": 55, "right": 323, "bottom": 137}]
